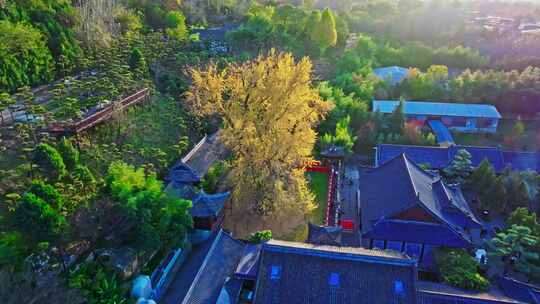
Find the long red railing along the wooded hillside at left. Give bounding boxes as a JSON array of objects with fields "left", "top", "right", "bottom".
[{"left": 49, "top": 88, "right": 150, "bottom": 133}]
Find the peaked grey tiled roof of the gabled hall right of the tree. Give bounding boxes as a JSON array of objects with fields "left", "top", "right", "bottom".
[{"left": 360, "top": 154, "right": 481, "bottom": 245}]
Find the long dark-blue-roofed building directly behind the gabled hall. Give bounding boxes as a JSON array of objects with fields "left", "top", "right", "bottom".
[{"left": 375, "top": 144, "right": 540, "bottom": 173}]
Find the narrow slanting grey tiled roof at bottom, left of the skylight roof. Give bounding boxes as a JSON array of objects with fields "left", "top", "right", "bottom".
[{"left": 182, "top": 230, "right": 244, "bottom": 304}]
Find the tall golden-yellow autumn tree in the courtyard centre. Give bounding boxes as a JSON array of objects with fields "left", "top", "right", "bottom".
[{"left": 187, "top": 50, "right": 331, "bottom": 221}]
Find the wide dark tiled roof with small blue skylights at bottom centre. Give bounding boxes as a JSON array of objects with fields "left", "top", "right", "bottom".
[{"left": 253, "top": 240, "right": 416, "bottom": 304}]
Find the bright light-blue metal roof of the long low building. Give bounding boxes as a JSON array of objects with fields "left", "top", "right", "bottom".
[{"left": 373, "top": 100, "right": 501, "bottom": 118}]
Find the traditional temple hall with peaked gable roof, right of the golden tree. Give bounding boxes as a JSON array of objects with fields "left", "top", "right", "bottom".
[{"left": 360, "top": 154, "right": 482, "bottom": 270}]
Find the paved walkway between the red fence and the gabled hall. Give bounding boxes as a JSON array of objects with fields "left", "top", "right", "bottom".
[{"left": 338, "top": 164, "right": 361, "bottom": 247}]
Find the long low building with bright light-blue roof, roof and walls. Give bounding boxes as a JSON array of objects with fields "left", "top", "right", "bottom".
[{"left": 373, "top": 100, "right": 501, "bottom": 133}]
